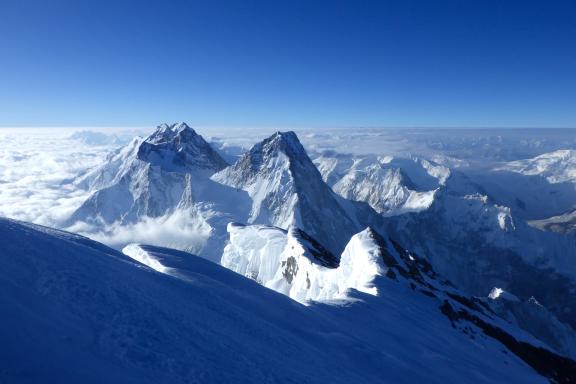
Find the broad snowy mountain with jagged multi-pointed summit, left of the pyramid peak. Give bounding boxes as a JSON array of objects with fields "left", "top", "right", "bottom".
[{"left": 70, "top": 123, "right": 233, "bottom": 224}]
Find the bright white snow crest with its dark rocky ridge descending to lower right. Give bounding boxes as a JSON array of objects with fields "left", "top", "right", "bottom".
[{"left": 215, "top": 219, "right": 573, "bottom": 380}]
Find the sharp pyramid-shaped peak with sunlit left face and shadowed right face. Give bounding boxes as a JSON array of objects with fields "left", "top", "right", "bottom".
[{"left": 212, "top": 132, "right": 359, "bottom": 254}]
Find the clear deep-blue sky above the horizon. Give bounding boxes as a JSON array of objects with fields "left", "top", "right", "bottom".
[{"left": 0, "top": 0, "right": 576, "bottom": 127}]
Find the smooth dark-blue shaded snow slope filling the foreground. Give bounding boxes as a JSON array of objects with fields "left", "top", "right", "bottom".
[{"left": 0, "top": 219, "right": 564, "bottom": 383}]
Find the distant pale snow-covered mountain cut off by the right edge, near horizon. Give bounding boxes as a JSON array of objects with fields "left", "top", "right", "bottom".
[{"left": 496, "top": 149, "right": 576, "bottom": 183}]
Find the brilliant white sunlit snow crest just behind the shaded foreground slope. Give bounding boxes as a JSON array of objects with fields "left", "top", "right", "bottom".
[{"left": 221, "top": 224, "right": 386, "bottom": 303}]
